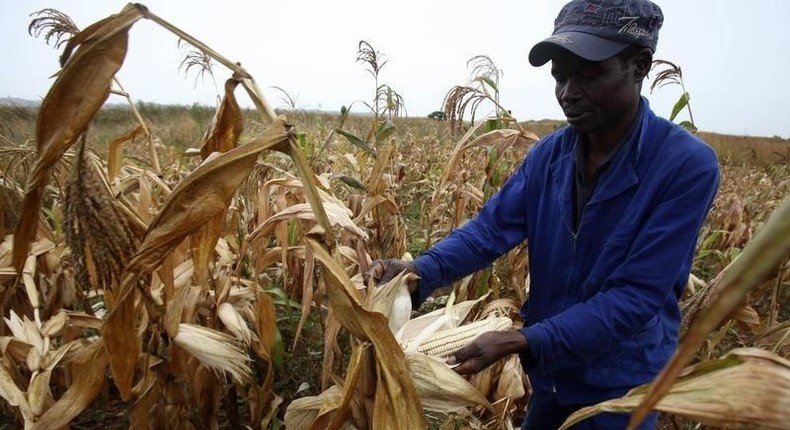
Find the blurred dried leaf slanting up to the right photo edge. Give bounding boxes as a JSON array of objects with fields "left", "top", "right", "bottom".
[{"left": 628, "top": 197, "right": 790, "bottom": 429}]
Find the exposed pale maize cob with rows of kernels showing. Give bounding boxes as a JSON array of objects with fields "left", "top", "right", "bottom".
[{"left": 404, "top": 317, "right": 513, "bottom": 358}]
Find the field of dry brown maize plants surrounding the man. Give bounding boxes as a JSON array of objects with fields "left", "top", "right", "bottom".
[{"left": 0, "top": 4, "right": 790, "bottom": 429}]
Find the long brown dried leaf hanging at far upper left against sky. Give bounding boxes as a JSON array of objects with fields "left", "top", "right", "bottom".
[{"left": 13, "top": 5, "right": 142, "bottom": 270}]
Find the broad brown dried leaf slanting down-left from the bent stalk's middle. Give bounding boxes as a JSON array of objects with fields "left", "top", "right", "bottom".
[{"left": 129, "top": 117, "right": 292, "bottom": 272}]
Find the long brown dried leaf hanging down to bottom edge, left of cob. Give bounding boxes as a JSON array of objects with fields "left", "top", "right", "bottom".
[{"left": 306, "top": 231, "right": 427, "bottom": 429}]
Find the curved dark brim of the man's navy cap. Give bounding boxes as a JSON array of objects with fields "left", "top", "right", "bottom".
[{"left": 529, "top": 31, "right": 628, "bottom": 67}]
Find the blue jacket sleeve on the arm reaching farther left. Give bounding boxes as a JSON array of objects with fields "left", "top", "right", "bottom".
[{"left": 412, "top": 157, "right": 530, "bottom": 304}]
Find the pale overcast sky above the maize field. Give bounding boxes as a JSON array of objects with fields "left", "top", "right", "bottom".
[{"left": 0, "top": 0, "right": 790, "bottom": 138}]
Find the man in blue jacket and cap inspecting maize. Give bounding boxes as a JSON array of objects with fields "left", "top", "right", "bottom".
[{"left": 369, "top": 0, "right": 719, "bottom": 430}]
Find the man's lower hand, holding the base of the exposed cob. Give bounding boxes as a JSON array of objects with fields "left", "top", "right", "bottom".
[{"left": 447, "top": 330, "right": 527, "bottom": 375}]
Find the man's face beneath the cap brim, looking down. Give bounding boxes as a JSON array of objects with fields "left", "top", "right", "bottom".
[{"left": 551, "top": 51, "right": 640, "bottom": 135}]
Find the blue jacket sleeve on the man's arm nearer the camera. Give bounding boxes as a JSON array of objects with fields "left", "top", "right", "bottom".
[{"left": 521, "top": 145, "right": 719, "bottom": 373}]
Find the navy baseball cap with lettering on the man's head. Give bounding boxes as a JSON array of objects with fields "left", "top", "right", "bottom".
[{"left": 529, "top": 0, "right": 664, "bottom": 67}]
